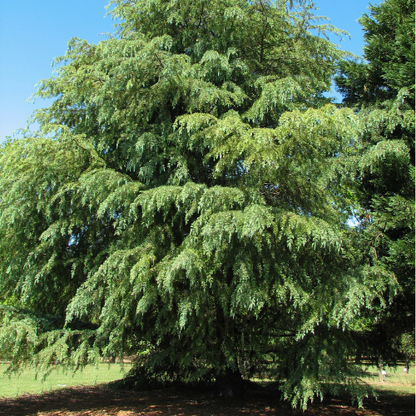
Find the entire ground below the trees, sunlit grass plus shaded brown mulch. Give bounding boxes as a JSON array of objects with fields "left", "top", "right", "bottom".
[{"left": 0, "top": 364, "right": 415, "bottom": 416}]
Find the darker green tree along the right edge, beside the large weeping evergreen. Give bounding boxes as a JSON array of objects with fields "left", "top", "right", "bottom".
[{"left": 337, "top": 0, "right": 415, "bottom": 365}]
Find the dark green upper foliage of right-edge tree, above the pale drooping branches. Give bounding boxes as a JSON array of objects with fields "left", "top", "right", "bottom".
[{"left": 337, "top": 0, "right": 415, "bottom": 108}]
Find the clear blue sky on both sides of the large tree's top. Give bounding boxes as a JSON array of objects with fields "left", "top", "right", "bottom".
[{"left": 0, "top": 0, "right": 380, "bottom": 142}]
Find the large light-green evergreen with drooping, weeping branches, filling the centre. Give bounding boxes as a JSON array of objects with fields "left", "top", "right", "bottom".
[{"left": 0, "top": 0, "right": 390, "bottom": 407}]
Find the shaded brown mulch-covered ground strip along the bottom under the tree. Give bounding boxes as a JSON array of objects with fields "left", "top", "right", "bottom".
[{"left": 0, "top": 386, "right": 415, "bottom": 416}]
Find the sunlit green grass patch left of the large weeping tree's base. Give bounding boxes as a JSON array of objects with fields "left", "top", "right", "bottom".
[{"left": 0, "top": 364, "right": 130, "bottom": 398}]
